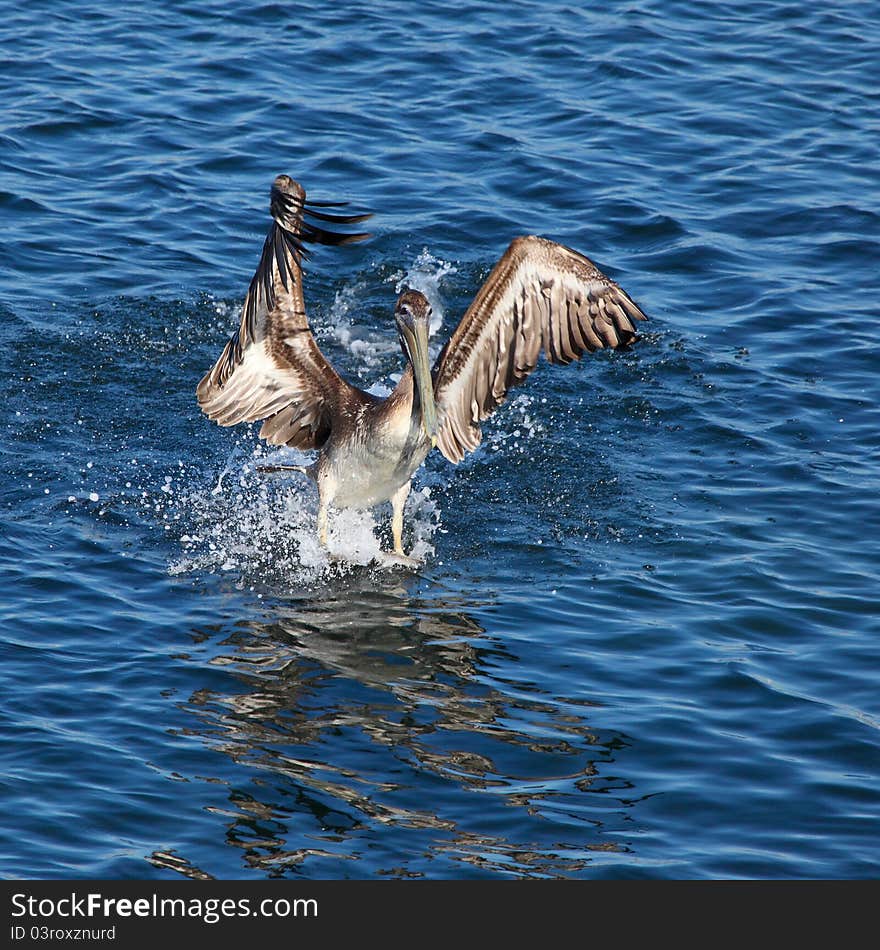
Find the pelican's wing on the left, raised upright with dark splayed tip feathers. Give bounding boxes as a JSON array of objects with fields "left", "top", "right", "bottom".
[{"left": 196, "top": 175, "right": 370, "bottom": 449}]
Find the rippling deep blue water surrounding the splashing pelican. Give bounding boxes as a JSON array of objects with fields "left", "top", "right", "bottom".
[{"left": 0, "top": 0, "right": 880, "bottom": 878}]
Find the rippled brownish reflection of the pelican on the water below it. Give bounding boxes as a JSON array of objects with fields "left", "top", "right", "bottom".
[{"left": 153, "top": 573, "right": 627, "bottom": 877}]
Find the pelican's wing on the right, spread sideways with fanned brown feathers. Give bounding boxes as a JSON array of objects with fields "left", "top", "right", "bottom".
[{"left": 434, "top": 237, "right": 647, "bottom": 462}]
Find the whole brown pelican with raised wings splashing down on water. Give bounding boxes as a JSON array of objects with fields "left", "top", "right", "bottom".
[{"left": 196, "top": 175, "right": 646, "bottom": 564}]
